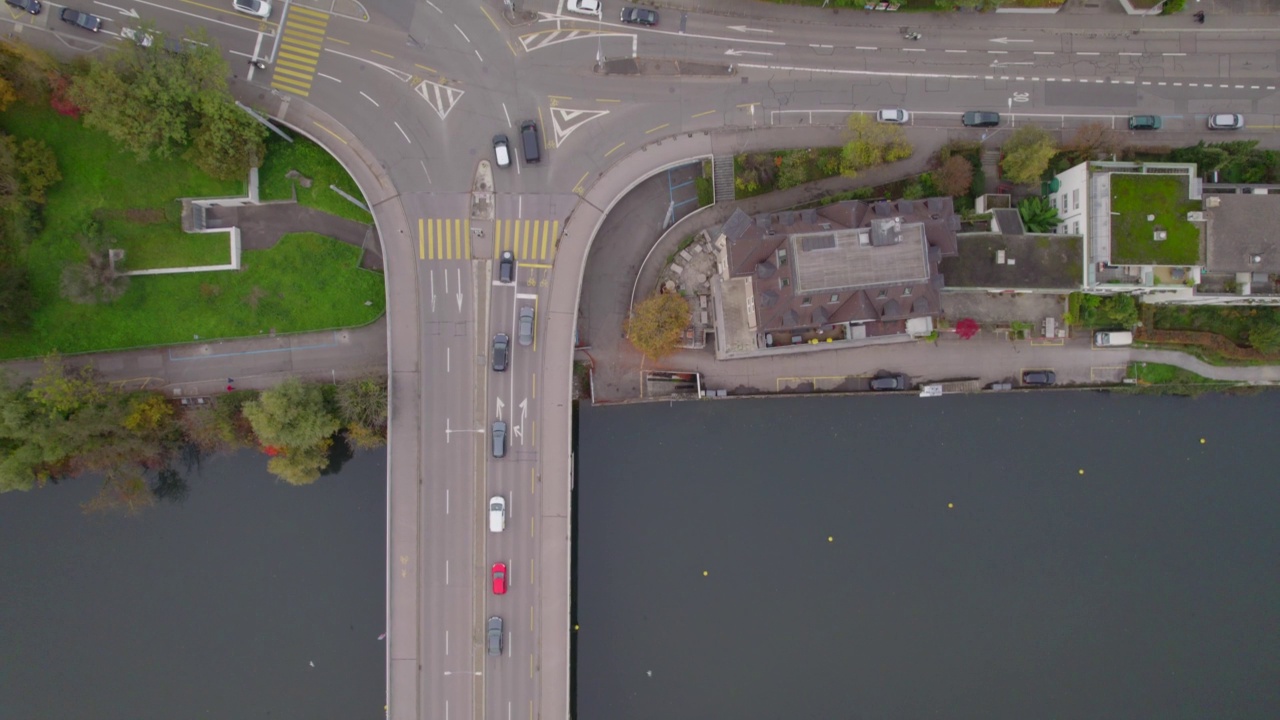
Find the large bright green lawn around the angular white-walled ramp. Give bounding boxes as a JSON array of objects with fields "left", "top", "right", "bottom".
[{"left": 0, "top": 105, "right": 384, "bottom": 357}]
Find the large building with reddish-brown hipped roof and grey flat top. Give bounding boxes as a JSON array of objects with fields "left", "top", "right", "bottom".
[{"left": 713, "top": 197, "right": 960, "bottom": 357}]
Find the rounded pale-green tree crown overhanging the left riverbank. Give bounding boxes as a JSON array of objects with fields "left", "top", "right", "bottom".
[{"left": 243, "top": 378, "right": 342, "bottom": 452}]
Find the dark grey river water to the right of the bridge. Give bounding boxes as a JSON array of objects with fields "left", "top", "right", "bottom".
[{"left": 576, "top": 392, "right": 1280, "bottom": 720}]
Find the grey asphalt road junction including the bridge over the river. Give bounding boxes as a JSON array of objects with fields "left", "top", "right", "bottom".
[{"left": 14, "top": 0, "right": 1280, "bottom": 720}]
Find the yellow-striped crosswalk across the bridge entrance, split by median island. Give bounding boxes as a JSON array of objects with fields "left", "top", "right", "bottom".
[{"left": 417, "top": 218, "right": 559, "bottom": 263}]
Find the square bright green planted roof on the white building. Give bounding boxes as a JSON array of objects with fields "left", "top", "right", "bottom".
[{"left": 1111, "top": 173, "right": 1201, "bottom": 265}]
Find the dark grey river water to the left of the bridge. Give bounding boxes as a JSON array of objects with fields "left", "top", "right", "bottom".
[{"left": 0, "top": 451, "right": 387, "bottom": 720}]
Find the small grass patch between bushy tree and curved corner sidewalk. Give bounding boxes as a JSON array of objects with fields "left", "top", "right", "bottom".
[{"left": 257, "top": 131, "right": 374, "bottom": 223}]
